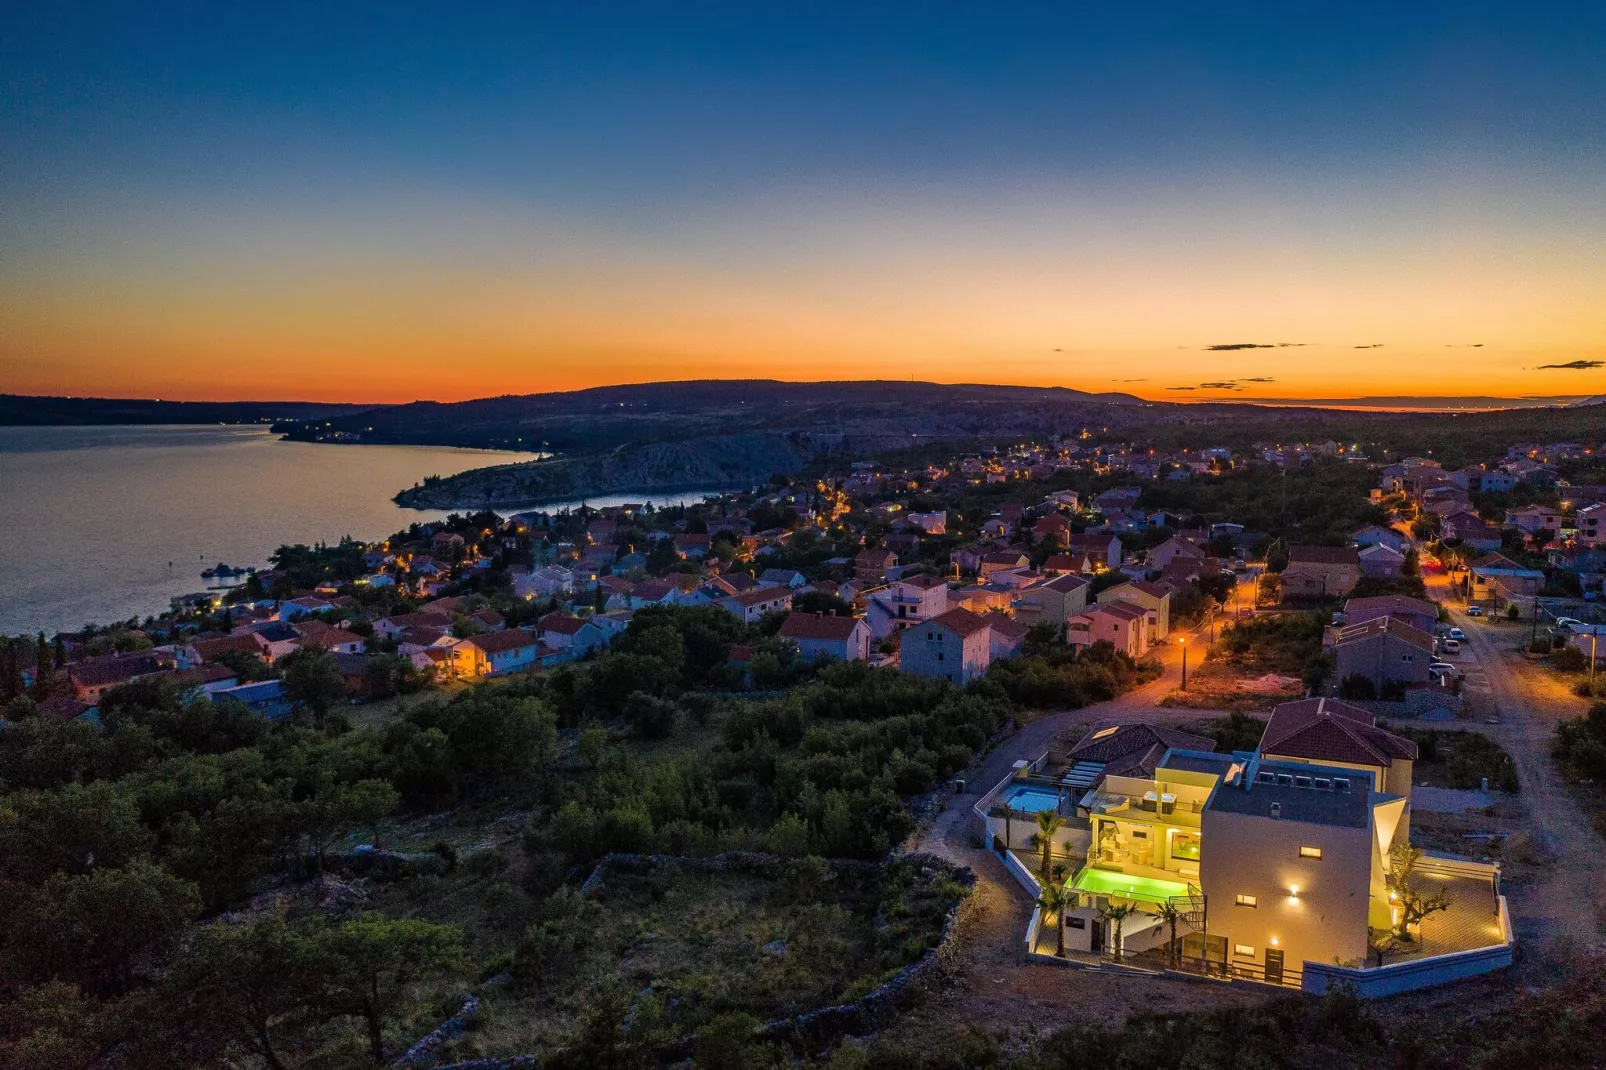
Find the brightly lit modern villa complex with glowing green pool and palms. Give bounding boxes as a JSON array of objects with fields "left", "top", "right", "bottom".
[{"left": 976, "top": 699, "right": 1511, "bottom": 996}]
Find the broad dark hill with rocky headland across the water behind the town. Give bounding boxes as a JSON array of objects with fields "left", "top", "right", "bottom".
[{"left": 367, "top": 379, "right": 1143, "bottom": 509}]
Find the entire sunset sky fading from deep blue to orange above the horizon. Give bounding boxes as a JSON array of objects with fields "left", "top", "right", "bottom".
[{"left": 0, "top": 0, "right": 1606, "bottom": 400}]
